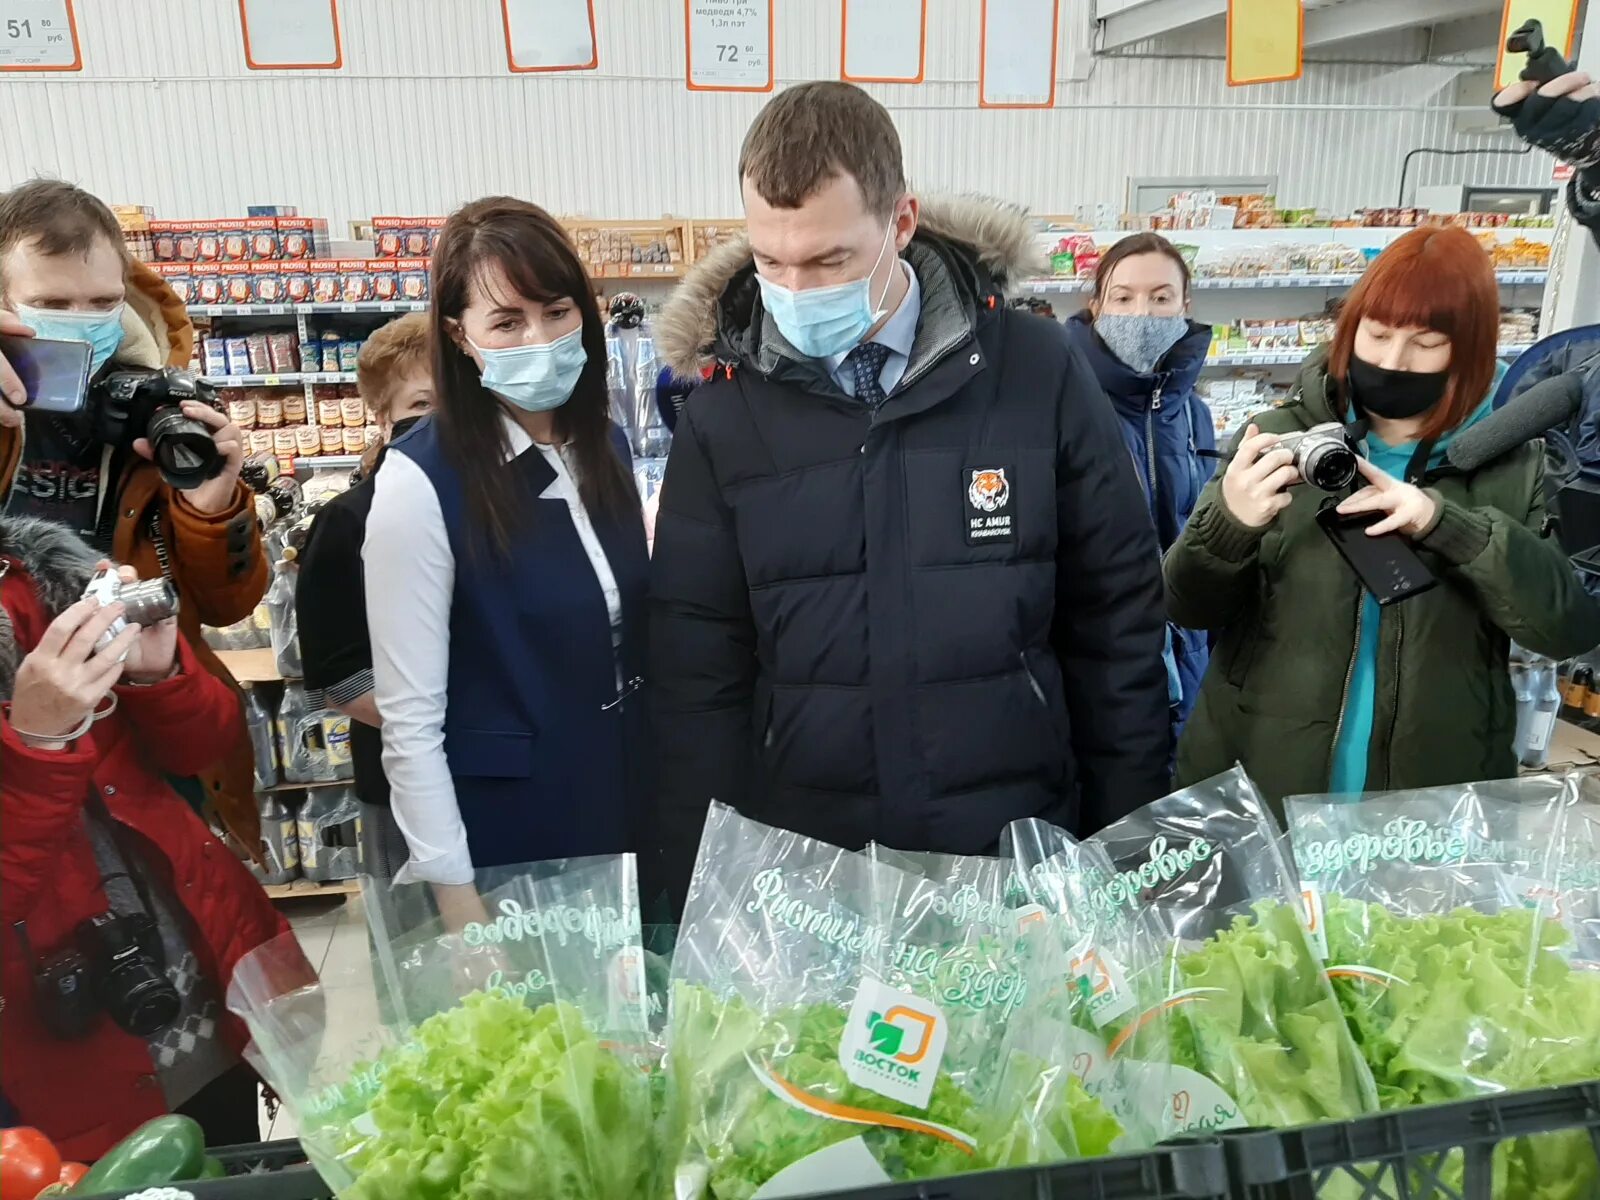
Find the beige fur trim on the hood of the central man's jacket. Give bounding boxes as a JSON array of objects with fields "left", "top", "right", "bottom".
[{"left": 654, "top": 195, "right": 1045, "bottom": 379}]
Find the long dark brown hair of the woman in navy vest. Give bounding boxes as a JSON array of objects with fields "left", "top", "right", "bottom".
[{"left": 432, "top": 195, "right": 640, "bottom": 555}]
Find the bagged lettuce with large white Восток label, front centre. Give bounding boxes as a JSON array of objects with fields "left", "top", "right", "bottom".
[{"left": 667, "top": 805, "right": 1120, "bottom": 1200}]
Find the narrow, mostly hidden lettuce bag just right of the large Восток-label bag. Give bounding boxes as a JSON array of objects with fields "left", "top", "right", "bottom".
[{"left": 1003, "top": 819, "right": 1184, "bottom": 1149}]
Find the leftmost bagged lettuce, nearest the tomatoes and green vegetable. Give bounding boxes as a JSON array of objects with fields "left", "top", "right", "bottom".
[{"left": 229, "top": 854, "right": 659, "bottom": 1200}]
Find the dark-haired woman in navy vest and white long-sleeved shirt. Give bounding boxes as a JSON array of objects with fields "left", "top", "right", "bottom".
[{"left": 362, "top": 197, "right": 650, "bottom": 923}]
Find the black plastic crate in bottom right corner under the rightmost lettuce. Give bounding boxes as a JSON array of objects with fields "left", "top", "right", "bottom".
[{"left": 1222, "top": 1080, "right": 1600, "bottom": 1200}]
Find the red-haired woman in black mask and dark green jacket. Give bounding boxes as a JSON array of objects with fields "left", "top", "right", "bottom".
[{"left": 1166, "top": 229, "right": 1600, "bottom": 802}]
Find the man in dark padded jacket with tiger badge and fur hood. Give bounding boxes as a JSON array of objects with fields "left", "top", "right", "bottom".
[{"left": 651, "top": 83, "right": 1168, "bottom": 899}]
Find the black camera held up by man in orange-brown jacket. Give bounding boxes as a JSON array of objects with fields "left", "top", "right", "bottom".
[{"left": 88, "top": 366, "right": 227, "bottom": 491}]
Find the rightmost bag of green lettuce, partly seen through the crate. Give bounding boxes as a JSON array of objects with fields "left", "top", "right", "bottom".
[{"left": 1285, "top": 776, "right": 1600, "bottom": 1200}]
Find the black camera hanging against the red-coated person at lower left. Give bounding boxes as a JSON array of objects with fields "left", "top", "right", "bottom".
[{"left": 34, "top": 912, "right": 182, "bottom": 1038}]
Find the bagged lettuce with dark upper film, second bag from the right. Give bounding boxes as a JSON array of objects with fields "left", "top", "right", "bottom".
[{"left": 1086, "top": 768, "right": 1376, "bottom": 1131}]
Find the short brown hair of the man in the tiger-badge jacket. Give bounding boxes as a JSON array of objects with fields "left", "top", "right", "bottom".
[{"left": 739, "top": 82, "right": 906, "bottom": 216}]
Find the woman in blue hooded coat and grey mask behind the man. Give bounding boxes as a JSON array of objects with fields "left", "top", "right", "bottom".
[{"left": 1067, "top": 234, "right": 1216, "bottom": 736}]
